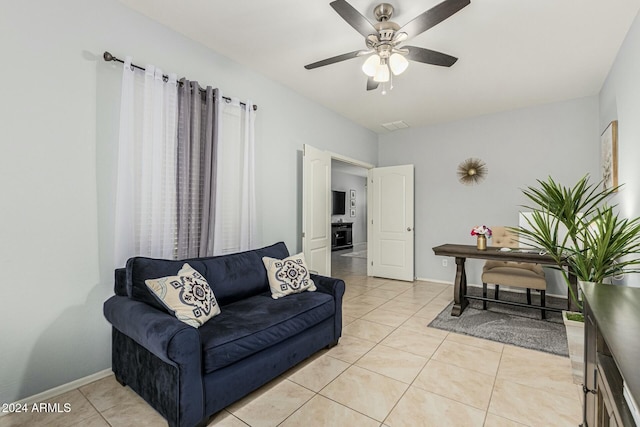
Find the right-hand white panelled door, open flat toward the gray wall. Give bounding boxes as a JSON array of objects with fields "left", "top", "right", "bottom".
[{"left": 368, "top": 165, "right": 414, "bottom": 281}]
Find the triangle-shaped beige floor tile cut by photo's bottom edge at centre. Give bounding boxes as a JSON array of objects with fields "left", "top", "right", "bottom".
[{"left": 280, "top": 395, "right": 380, "bottom": 427}]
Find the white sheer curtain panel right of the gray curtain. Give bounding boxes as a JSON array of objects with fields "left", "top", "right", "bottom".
[{"left": 213, "top": 98, "right": 257, "bottom": 255}]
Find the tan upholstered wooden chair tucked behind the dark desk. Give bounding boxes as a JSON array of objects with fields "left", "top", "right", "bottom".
[{"left": 482, "top": 226, "right": 547, "bottom": 319}]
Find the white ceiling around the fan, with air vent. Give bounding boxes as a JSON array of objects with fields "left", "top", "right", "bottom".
[{"left": 121, "top": 0, "right": 640, "bottom": 133}]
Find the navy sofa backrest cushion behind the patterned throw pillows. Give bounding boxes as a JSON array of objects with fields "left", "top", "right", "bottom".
[{"left": 127, "top": 242, "right": 289, "bottom": 311}]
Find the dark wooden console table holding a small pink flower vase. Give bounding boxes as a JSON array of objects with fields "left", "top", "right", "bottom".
[{"left": 433, "top": 244, "right": 578, "bottom": 316}]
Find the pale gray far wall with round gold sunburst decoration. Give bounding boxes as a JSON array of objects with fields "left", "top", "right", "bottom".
[{"left": 379, "top": 97, "right": 600, "bottom": 294}]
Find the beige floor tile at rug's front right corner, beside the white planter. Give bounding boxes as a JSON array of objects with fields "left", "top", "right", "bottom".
[{"left": 498, "top": 346, "right": 578, "bottom": 399}]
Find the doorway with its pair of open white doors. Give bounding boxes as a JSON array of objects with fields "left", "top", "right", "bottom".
[{"left": 302, "top": 144, "right": 414, "bottom": 281}]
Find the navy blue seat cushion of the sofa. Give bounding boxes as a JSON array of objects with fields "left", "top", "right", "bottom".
[{"left": 199, "top": 292, "right": 335, "bottom": 373}]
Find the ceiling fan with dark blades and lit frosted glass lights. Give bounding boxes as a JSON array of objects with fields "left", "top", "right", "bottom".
[{"left": 304, "top": 0, "right": 471, "bottom": 95}]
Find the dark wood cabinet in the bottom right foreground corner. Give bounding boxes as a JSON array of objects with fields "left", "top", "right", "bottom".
[{"left": 581, "top": 283, "right": 640, "bottom": 427}]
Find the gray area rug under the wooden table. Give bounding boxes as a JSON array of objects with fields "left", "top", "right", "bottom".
[{"left": 429, "top": 287, "right": 569, "bottom": 356}]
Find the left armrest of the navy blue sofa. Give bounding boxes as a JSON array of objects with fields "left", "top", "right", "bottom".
[{"left": 104, "top": 295, "right": 201, "bottom": 366}]
